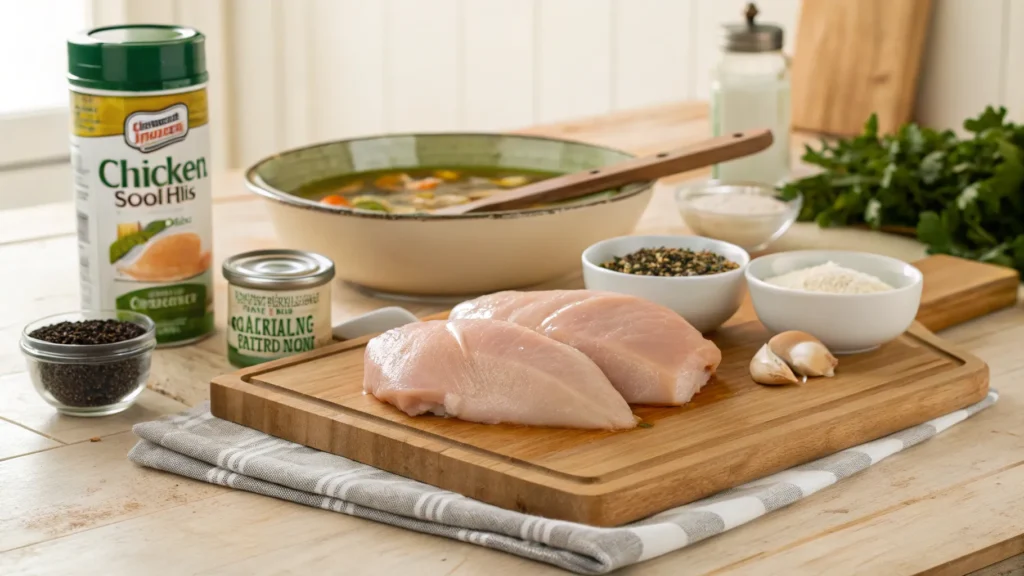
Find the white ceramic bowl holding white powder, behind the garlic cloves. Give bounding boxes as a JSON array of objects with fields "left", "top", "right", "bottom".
[{"left": 746, "top": 250, "right": 924, "bottom": 354}]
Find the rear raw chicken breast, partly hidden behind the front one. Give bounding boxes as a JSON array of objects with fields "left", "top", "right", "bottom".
[{"left": 451, "top": 290, "right": 722, "bottom": 406}]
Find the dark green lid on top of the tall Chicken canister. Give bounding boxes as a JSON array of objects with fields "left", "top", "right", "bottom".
[{"left": 68, "top": 24, "right": 209, "bottom": 91}]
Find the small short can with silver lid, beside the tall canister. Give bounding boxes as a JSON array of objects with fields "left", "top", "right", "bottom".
[{"left": 223, "top": 250, "right": 334, "bottom": 367}]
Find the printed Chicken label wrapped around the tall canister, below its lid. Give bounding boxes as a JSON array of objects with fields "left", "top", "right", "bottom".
[{"left": 71, "top": 87, "right": 213, "bottom": 344}]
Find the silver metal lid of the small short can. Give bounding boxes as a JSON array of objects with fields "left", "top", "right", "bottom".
[{"left": 223, "top": 249, "right": 334, "bottom": 290}]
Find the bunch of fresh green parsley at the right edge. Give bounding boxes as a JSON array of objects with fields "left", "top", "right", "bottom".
[{"left": 781, "top": 107, "right": 1024, "bottom": 272}]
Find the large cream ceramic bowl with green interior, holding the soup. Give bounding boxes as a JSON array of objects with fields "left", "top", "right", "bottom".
[{"left": 246, "top": 133, "right": 651, "bottom": 296}]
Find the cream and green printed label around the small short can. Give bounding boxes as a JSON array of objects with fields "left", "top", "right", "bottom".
[{"left": 227, "top": 283, "right": 331, "bottom": 367}]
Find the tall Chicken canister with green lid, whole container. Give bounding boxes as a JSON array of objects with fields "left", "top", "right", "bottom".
[{"left": 68, "top": 25, "right": 213, "bottom": 345}]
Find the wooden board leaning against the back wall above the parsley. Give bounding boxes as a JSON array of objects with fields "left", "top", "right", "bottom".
[{"left": 793, "top": 0, "right": 932, "bottom": 135}]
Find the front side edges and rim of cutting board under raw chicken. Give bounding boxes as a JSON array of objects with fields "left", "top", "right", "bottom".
[{"left": 211, "top": 325, "right": 988, "bottom": 526}]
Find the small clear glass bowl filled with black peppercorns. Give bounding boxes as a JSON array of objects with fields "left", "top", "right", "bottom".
[{"left": 22, "top": 311, "right": 157, "bottom": 416}]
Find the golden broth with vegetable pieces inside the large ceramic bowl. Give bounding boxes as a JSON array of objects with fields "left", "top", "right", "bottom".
[{"left": 296, "top": 167, "right": 617, "bottom": 214}]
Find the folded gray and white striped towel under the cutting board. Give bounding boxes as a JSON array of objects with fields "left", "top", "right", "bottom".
[{"left": 128, "top": 390, "right": 998, "bottom": 574}]
